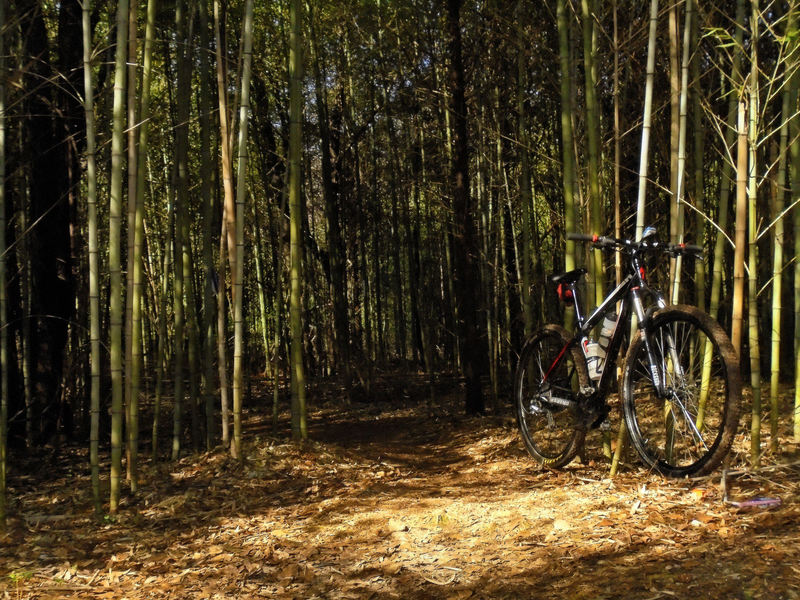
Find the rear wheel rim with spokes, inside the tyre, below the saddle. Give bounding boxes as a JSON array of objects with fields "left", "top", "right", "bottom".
[{"left": 517, "top": 332, "right": 580, "bottom": 461}]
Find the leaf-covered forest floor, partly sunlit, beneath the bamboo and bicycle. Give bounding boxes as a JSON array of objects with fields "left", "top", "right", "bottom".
[{"left": 0, "top": 376, "right": 800, "bottom": 600}]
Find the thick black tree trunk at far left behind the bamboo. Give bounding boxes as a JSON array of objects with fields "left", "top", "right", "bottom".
[{"left": 19, "top": 0, "right": 79, "bottom": 437}]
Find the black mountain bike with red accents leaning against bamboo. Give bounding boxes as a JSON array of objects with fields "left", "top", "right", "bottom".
[{"left": 514, "top": 227, "right": 741, "bottom": 477}]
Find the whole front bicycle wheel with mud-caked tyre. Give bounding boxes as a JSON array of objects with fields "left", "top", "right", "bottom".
[{"left": 622, "top": 305, "right": 741, "bottom": 477}]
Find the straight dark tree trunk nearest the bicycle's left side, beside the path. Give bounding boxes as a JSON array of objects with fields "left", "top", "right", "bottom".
[{"left": 447, "top": 0, "right": 488, "bottom": 413}]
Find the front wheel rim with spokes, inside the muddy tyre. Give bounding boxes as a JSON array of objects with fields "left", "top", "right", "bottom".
[{"left": 627, "top": 317, "right": 729, "bottom": 474}]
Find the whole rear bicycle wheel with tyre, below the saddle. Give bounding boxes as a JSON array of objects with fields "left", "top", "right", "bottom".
[{"left": 514, "top": 325, "right": 589, "bottom": 469}]
